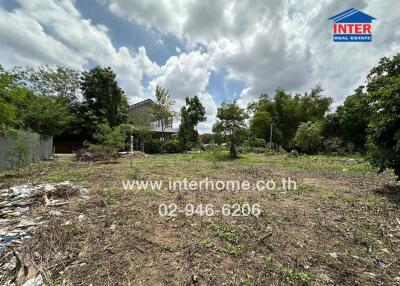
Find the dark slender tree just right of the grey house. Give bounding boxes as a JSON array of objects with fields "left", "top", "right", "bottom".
[{"left": 178, "top": 95, "right": 207, "bottom": 149}]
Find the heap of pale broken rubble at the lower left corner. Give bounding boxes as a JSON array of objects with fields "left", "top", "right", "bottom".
[{"left": 0, "top": 181, "right": 89, "bottom": 286}]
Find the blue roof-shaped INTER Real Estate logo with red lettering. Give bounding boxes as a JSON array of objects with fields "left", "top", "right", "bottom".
[{"left": 329, "top": 8, "right": 376, "bottom": 42}]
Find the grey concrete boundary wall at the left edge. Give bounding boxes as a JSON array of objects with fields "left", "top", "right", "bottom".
[{"left": 0, "top": 130, "right": 53, "bottom": 170}]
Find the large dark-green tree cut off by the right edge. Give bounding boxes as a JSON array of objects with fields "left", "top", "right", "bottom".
[{"left": 367, "top": 54, "right": 400, "bottom": 180}]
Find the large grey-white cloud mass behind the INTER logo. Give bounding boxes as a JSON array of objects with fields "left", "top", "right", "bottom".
[{"left": 106, "top": 0, "right": 400, "bottom": 108}]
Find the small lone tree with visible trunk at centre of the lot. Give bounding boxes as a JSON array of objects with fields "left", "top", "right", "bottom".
[{"left": 213, "top": 101, "right": 248, "bottom": 159}]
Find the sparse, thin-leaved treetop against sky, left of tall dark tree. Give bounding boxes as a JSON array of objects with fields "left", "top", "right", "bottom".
[{"left": 12, "top": 65, "right": 80, "bottom": 102}]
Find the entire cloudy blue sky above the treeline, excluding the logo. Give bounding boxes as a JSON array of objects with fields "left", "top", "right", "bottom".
[{"left": 0, "top": 0, "right": 400, "bottom": 132}]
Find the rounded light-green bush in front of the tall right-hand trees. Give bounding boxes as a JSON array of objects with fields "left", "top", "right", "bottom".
[{"left": 293, "top": 121, "right": 322, "bottom": 154}]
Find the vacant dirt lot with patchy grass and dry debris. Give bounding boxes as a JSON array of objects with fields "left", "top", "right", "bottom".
[{"left": 0, "top": 153, "right": 400, "bottom": 285}]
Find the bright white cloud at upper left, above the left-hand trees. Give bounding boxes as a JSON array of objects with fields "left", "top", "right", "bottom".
[{"left": 0, "top": 0, "right": 159, "bottom": 101}]
